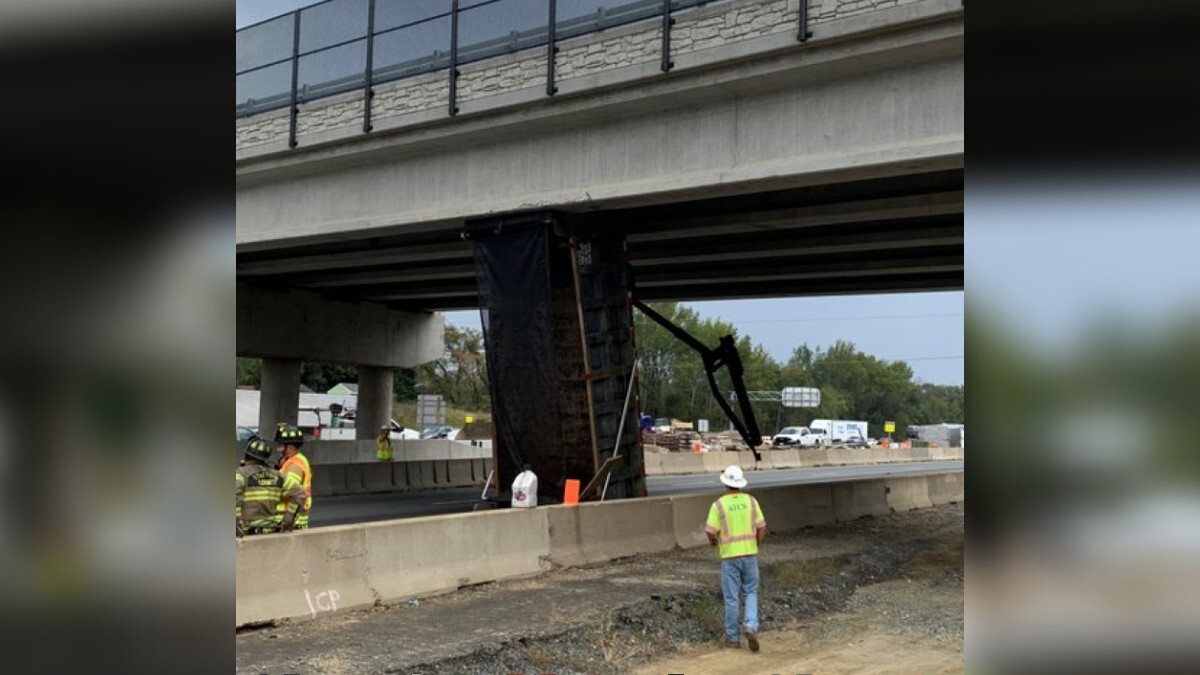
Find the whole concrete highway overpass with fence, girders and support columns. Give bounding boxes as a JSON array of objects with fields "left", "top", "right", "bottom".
[{"left": 236, "top": 0, "right": 964, "bottom": 496}]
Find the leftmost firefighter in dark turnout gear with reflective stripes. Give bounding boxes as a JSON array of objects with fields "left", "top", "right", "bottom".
[{"left": 234, "top": 436, "right": 305, "bottom": 537}]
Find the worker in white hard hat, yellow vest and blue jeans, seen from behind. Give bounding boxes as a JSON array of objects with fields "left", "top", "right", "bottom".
[{"left": 704, "top": 464, "right": 767, "bottom": 651}]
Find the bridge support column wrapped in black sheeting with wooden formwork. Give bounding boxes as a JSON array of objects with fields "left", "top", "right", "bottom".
[{"left": 467, "top": 213, "right": 646, "bottom": 503}]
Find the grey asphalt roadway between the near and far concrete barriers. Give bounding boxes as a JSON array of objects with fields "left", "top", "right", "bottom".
[{"left": 308, "top": 460, "right": 962, "bottom": 527}]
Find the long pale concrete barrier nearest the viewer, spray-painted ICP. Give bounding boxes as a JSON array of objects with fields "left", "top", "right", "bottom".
[{"left": 235, "top": 470, "right": 964, "bottom": 626}]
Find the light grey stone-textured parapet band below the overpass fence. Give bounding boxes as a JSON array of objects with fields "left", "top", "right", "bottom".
[{"left": 236, "top": 0, "right": 936, "bottom": 153}]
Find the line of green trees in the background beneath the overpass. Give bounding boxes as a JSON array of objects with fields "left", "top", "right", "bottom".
[{"left": 238, "top": 303, "right": 966, "bottom": 437}]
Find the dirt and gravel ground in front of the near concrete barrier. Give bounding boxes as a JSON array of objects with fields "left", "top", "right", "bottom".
[{"left": 236, "top": 504, "right": 964, "bottom": 675}]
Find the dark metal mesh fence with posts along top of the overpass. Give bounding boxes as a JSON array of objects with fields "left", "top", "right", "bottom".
[{"left": 235, "top": 0, "right": 811, "bottom": 148}]
